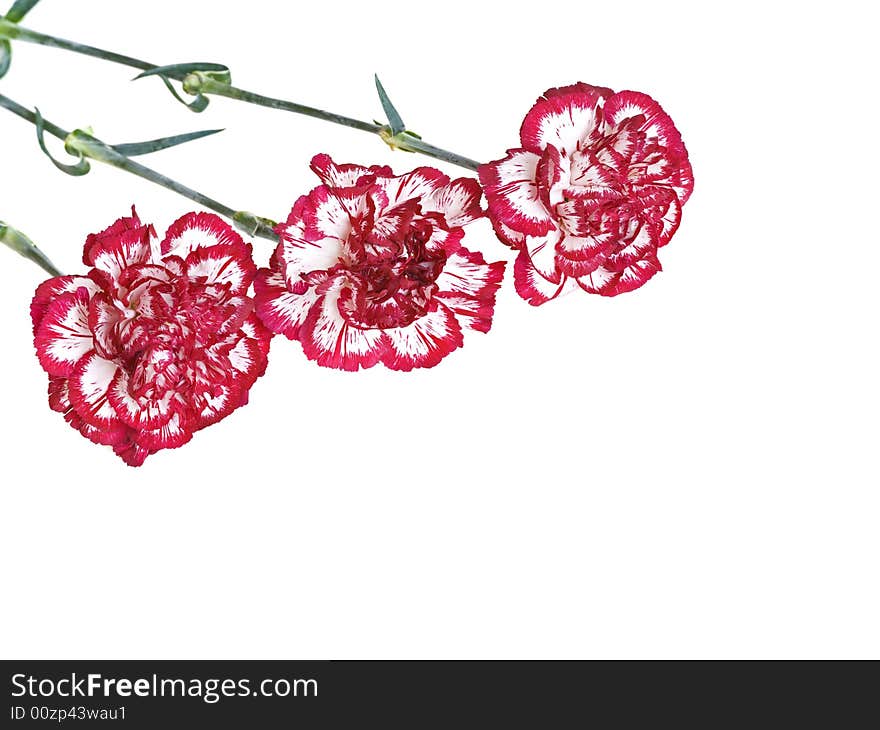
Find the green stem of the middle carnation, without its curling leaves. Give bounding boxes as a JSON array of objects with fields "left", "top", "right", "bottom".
[{"left": 0, "top": 94, "right": 278, "bottom": 242}]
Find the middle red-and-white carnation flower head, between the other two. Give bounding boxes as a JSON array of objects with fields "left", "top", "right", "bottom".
[{"left": 254, "top": 155, "right": 504, "bottom": 370}]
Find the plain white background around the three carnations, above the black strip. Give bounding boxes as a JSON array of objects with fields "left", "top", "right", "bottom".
[{"left": 0, "top": 0, "right": 880, "bottom": 658}]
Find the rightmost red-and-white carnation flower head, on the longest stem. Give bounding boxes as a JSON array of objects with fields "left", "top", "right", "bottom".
[{"left": 480, "top": 83, "right": 693, "bottom": 305}]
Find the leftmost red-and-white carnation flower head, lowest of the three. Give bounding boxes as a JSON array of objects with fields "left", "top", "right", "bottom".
[{"left": 31, "top": 208, "right": 271, "bottom": 466}]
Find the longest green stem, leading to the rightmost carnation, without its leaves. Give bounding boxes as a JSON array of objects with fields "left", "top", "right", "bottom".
[{"left": 0, "top": 18, "right": 480, "bottom": 170}]
